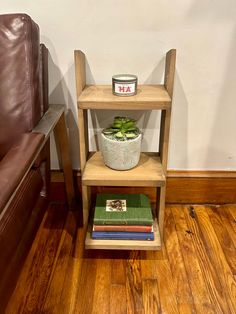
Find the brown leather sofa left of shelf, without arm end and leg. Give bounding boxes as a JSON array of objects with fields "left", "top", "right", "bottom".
[{"left": 0, "top": 14, "right": 50, "bottom": 313}]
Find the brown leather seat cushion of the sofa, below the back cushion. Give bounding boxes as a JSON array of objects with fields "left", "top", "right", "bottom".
[{"left": 0, "top": 133, "right": 44, "bottom": 213}]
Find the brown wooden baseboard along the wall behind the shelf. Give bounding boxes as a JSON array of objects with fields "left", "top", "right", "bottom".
[{"left": 51, "top": 170, "right": 236, "bottom": 204}]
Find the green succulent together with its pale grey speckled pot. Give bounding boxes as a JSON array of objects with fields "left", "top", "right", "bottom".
[{"left": 101, "top": 117, "right": 142, "bottom": 170}]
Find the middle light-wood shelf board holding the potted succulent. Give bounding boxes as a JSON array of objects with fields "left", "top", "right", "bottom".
[{"left": 82, "top": 152, "right": 166, "bottom": 187}]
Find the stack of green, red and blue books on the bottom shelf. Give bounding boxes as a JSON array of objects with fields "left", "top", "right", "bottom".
[{"left": 92, "top": 194, "right": 154, "bottom": 240}]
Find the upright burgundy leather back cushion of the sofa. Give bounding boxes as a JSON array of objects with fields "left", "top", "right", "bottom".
[{"left": 0, "top": 14, "right": 43, "bottom": 159}]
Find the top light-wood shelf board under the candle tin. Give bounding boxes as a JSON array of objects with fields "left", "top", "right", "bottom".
[{"left": 78, "top": 85, "right": 171, "bottom": 110}]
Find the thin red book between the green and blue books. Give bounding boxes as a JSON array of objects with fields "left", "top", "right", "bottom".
[{"left": 93, "top": 225, "right": 153, "bottom": 232}]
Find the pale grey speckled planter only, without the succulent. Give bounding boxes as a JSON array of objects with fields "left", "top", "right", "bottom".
[{"left": 101, "top": 133, "right": 142, "bottom": 170}]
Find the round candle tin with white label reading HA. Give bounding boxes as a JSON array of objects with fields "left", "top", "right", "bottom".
[{"left": 112, "top": 74, "right": 138, "bottom": 96}]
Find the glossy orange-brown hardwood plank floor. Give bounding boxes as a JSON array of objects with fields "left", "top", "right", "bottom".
[{"left": 6, "top": 204, "right": 236, "bottom": 314}]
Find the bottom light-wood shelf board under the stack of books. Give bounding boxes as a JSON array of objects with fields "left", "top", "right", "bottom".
[{"left": 85, "top": 220, "right": 161, "bottom": 251}]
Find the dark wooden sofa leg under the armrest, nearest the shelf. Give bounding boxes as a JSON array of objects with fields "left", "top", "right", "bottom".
[{"left": 54, "top": 112, "right": 75, "bottom": 209}]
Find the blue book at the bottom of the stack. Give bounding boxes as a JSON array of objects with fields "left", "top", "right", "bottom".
[{"left": 92, "top": 231, "right": 154, "bottom": 241}]
